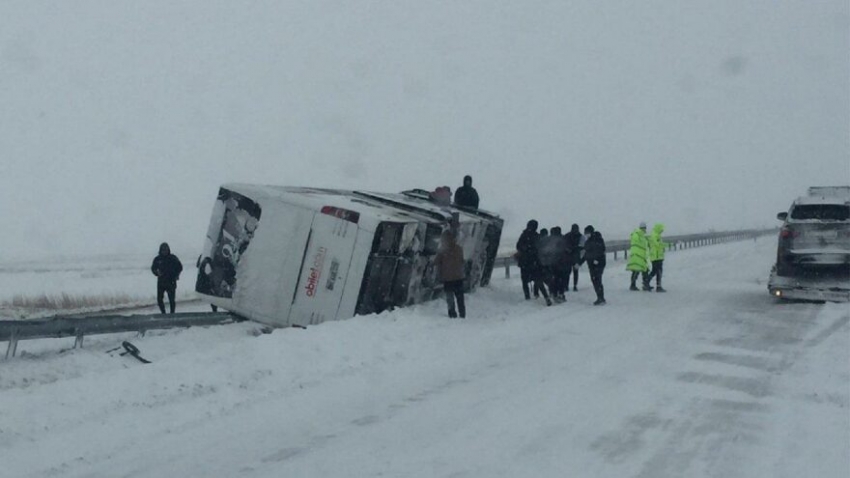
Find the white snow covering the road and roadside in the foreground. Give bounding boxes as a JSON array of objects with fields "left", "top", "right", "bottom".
[{"left": 0, "top": 238, "right": 850, "bottom": 478}]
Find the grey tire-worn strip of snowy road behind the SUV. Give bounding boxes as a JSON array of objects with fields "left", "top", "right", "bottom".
[{"left": 636, "top": 298, "right": 824, "bottom": 478}]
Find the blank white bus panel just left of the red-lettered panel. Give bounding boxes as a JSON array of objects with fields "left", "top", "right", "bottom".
[{"left": 231, "top": 201, "right": 313, "bottom": 327}]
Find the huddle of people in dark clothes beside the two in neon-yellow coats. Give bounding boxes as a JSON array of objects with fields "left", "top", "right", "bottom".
[{"left": 515, "top": 219, "right": 605, "bottom": 305}]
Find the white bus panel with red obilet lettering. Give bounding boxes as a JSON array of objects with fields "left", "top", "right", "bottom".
[{"left": 289, "top": 213, "right": 358, "bottom": 326}]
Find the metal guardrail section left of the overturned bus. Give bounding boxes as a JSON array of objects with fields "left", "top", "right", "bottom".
[{"left": 0, "top": 312, "right": 238, "bottom": 359}]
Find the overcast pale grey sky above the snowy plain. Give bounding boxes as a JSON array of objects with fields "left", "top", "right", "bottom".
[{"left": 0, "top": 0, "right": 850, "bottom": 260}]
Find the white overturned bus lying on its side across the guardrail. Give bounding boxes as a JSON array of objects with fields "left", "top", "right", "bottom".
[{"left": 195, "top": 184, "right": 503, "bottom": 327}]
